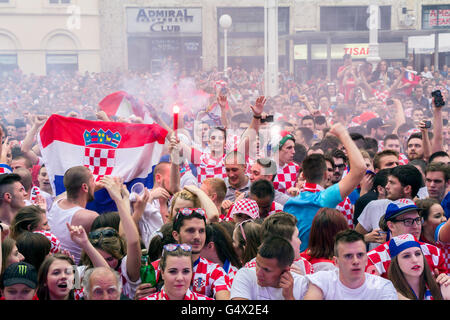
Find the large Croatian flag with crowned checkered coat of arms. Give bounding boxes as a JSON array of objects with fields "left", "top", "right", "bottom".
[{"left": 38, "top": 115, "right": 167, "bottom": 213}]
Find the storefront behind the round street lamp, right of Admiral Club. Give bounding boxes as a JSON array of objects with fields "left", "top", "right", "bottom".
[{"left": 217, "top": 7, "right": 289, "bottom": 70}]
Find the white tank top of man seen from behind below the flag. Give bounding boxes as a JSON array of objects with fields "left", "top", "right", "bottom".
[{"left": 47, "top": 199, "right": 83, "bottom": 265}]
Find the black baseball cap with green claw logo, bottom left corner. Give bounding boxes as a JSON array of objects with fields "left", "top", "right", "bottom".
[{"left": 2, "top": 262, "right": 38, "bottom": 289}]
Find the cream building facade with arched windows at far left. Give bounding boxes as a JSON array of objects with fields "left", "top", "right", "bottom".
[{"left": 0, "top": 0, "right": 101, "bottom": 75}]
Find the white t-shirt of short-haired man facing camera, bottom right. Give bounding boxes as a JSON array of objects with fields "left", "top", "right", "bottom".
[{"left": 306, "top": 269, "right": 398, "bottom": 300}]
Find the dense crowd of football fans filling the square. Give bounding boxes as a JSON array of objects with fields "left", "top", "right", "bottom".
[{"left": 0, "top": 55, "right": 450, "bottom": 300}]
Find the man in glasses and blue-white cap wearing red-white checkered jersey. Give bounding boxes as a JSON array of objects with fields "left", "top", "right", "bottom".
[{"left": 366, "top": 199, "right": 448, "bottom": 278}]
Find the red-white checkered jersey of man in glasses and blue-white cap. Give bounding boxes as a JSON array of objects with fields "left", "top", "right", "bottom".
[{"left": 366, "top": 241, "right": 448, "bottom": 279}]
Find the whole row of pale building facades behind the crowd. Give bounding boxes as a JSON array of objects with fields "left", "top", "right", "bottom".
[{"left": 0, "top": 0, "right": 450, "bottom": 77}]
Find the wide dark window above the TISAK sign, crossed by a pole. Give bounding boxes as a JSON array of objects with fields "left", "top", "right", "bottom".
[{"left": 320, "top": 6, "right": 391, "bottom": 31}]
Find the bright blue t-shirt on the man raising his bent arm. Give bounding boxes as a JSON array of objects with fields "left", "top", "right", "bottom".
[{"left": 283, "top": 183, "right": 343, "bottom": 252}]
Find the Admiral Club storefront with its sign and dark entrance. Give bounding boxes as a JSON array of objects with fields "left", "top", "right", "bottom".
[{"left": 126, "top": 7, "right": 202, "bottom": 73}]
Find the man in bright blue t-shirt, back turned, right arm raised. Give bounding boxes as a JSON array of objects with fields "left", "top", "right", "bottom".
[{"left": 283, "top": 123, "right": 366, "bottom": 251}]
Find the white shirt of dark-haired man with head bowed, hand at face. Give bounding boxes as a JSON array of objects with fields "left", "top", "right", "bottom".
[{"left": 230, "top": 268, "right": 308, "bottom": 300}]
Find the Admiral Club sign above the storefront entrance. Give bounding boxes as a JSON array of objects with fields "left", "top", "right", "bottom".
[{"left": 126, "top": 7, "right": 202, "bottom": 34}]
